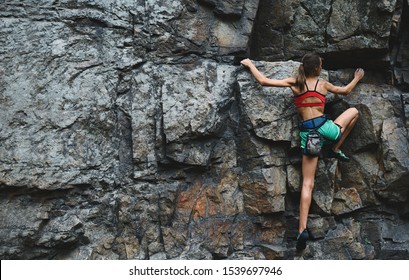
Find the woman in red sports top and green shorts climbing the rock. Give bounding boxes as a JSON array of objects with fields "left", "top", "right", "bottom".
[{"left": 241, "top": 53, "right": 364, "bottom": 250}]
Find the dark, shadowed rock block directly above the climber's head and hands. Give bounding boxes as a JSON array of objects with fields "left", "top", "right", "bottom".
[{"left": 251, "top": 0, "right": 396, "bottom": 67}]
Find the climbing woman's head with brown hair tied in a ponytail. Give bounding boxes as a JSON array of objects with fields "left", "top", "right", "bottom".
[{"left": 296, "top": 53, "right": 322, "bottom": 90}]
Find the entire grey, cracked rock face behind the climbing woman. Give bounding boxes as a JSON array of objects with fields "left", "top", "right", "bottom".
[{"left": 0, "top": 0, "right": 409, "bottom": 259}]
